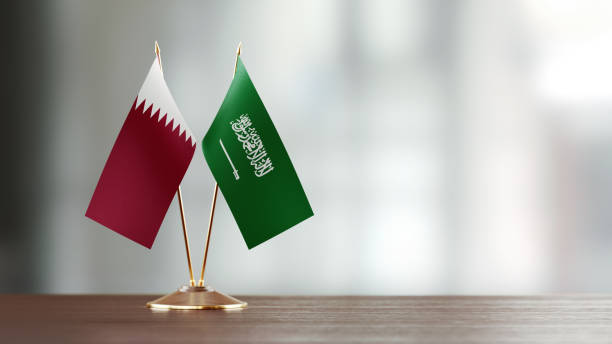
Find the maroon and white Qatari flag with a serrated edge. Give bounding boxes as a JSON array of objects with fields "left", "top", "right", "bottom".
[{"left": 85, "top": 53, "right": 196, "bottom": 248}]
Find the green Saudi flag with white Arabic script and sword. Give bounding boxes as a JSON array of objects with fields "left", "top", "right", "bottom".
[{"left": 202, "top": 57, "right": 313, "bottom": 248}]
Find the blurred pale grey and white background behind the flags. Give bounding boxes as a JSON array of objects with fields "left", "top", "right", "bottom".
[{"left": 0, "top": 0, "right": 612, "bottom": 294}]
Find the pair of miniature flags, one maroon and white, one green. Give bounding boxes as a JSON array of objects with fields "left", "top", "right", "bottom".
[{"left": 85, "top": 46, "right": 313, "bottom": 249}]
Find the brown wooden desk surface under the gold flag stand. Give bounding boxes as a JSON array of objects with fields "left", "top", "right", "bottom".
[{"left": 0, "top": 295, "right": 612, "bottom": 343}]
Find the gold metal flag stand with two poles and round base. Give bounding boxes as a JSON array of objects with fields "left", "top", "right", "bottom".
[{"left": 147, "top": 42, "right": 247, "bottom": 310}]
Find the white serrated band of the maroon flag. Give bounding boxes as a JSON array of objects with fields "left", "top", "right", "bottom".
[{"left": 136, "top": 57, "right": 196, "bottom": 145}]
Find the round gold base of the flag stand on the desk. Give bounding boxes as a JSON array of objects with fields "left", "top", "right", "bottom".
[{"left": 147, "top": 286, "right": 247, "bottom": 310}]
